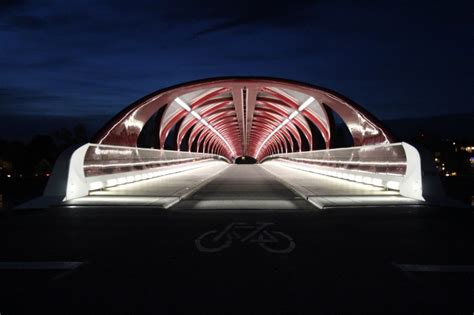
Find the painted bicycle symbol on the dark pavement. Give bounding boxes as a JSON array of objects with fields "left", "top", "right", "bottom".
[{"left": 194, "top": 222, "right": 296, "bottom": 254}]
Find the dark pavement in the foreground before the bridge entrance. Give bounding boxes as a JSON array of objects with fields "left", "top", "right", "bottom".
[{"left": 0, "top": 208, "right": 474, "bottom": 315}]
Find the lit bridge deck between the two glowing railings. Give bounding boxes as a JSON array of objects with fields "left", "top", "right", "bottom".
[{"left": 68, "top": 162, "right": 417, "bottom": 210}]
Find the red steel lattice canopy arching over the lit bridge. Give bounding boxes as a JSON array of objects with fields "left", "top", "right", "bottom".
[{"left": 93, "top": 77, "right": 393, "bottom": 160}]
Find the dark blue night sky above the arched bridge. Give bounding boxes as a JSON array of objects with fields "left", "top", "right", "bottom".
[{"left": 0, "top": 0, "right": 474, "bottom": 139}]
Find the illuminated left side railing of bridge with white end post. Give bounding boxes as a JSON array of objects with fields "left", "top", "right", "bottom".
[{"left": 44, "top": 143, "right": 231, "bottom": 201}]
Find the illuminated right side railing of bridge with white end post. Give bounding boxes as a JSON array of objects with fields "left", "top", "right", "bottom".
[{"left": 262, "top": 142, "right": 423, "bottom": 200}]
